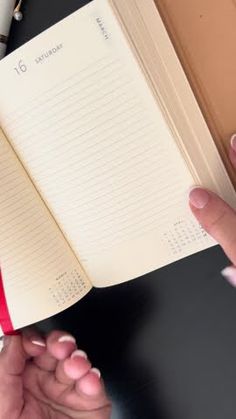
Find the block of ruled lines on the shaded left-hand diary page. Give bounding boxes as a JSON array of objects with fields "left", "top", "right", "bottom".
[{"left": 0, "top": 131, "right": 85, "bottom": 297}]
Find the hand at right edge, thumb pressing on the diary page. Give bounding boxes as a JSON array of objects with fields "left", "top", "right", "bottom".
[{"left": 189, "top": 135, "right": 236, "bottom": 286}]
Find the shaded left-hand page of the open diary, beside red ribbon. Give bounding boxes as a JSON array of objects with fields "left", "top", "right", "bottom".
[{"left": 0, "top": 130, "right": 90, "bottom": 334}]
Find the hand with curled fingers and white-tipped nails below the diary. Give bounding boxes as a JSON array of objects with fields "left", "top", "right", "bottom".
[{"left": 0, "top": 331, "right": 111, "bottom": 419}]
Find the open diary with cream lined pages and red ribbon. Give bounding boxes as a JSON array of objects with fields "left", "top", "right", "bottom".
[{"left": 0, "top": 0, "right": 236, "bottom": 333}]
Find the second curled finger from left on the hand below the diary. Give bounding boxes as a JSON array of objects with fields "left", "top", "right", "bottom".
[{"left": 34, "top": 330, "right": 76, "bottom": 371}]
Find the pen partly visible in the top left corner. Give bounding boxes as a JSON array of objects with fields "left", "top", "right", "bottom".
[{"left": 0, "top": 0, "right": 20, "bottom": 59}]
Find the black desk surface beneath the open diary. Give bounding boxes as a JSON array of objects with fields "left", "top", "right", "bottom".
[{"left": 6, "top": 0, "right": 236, "bottom": 419}]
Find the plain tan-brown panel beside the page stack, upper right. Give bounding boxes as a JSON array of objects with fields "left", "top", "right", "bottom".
[{"left": 155, "top": 0, "right": 236, "bottom": 186}]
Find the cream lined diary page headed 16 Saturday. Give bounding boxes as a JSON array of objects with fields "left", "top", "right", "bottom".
[{"left": 0, "top": 0, "right": 215, "bottom": 286}]
